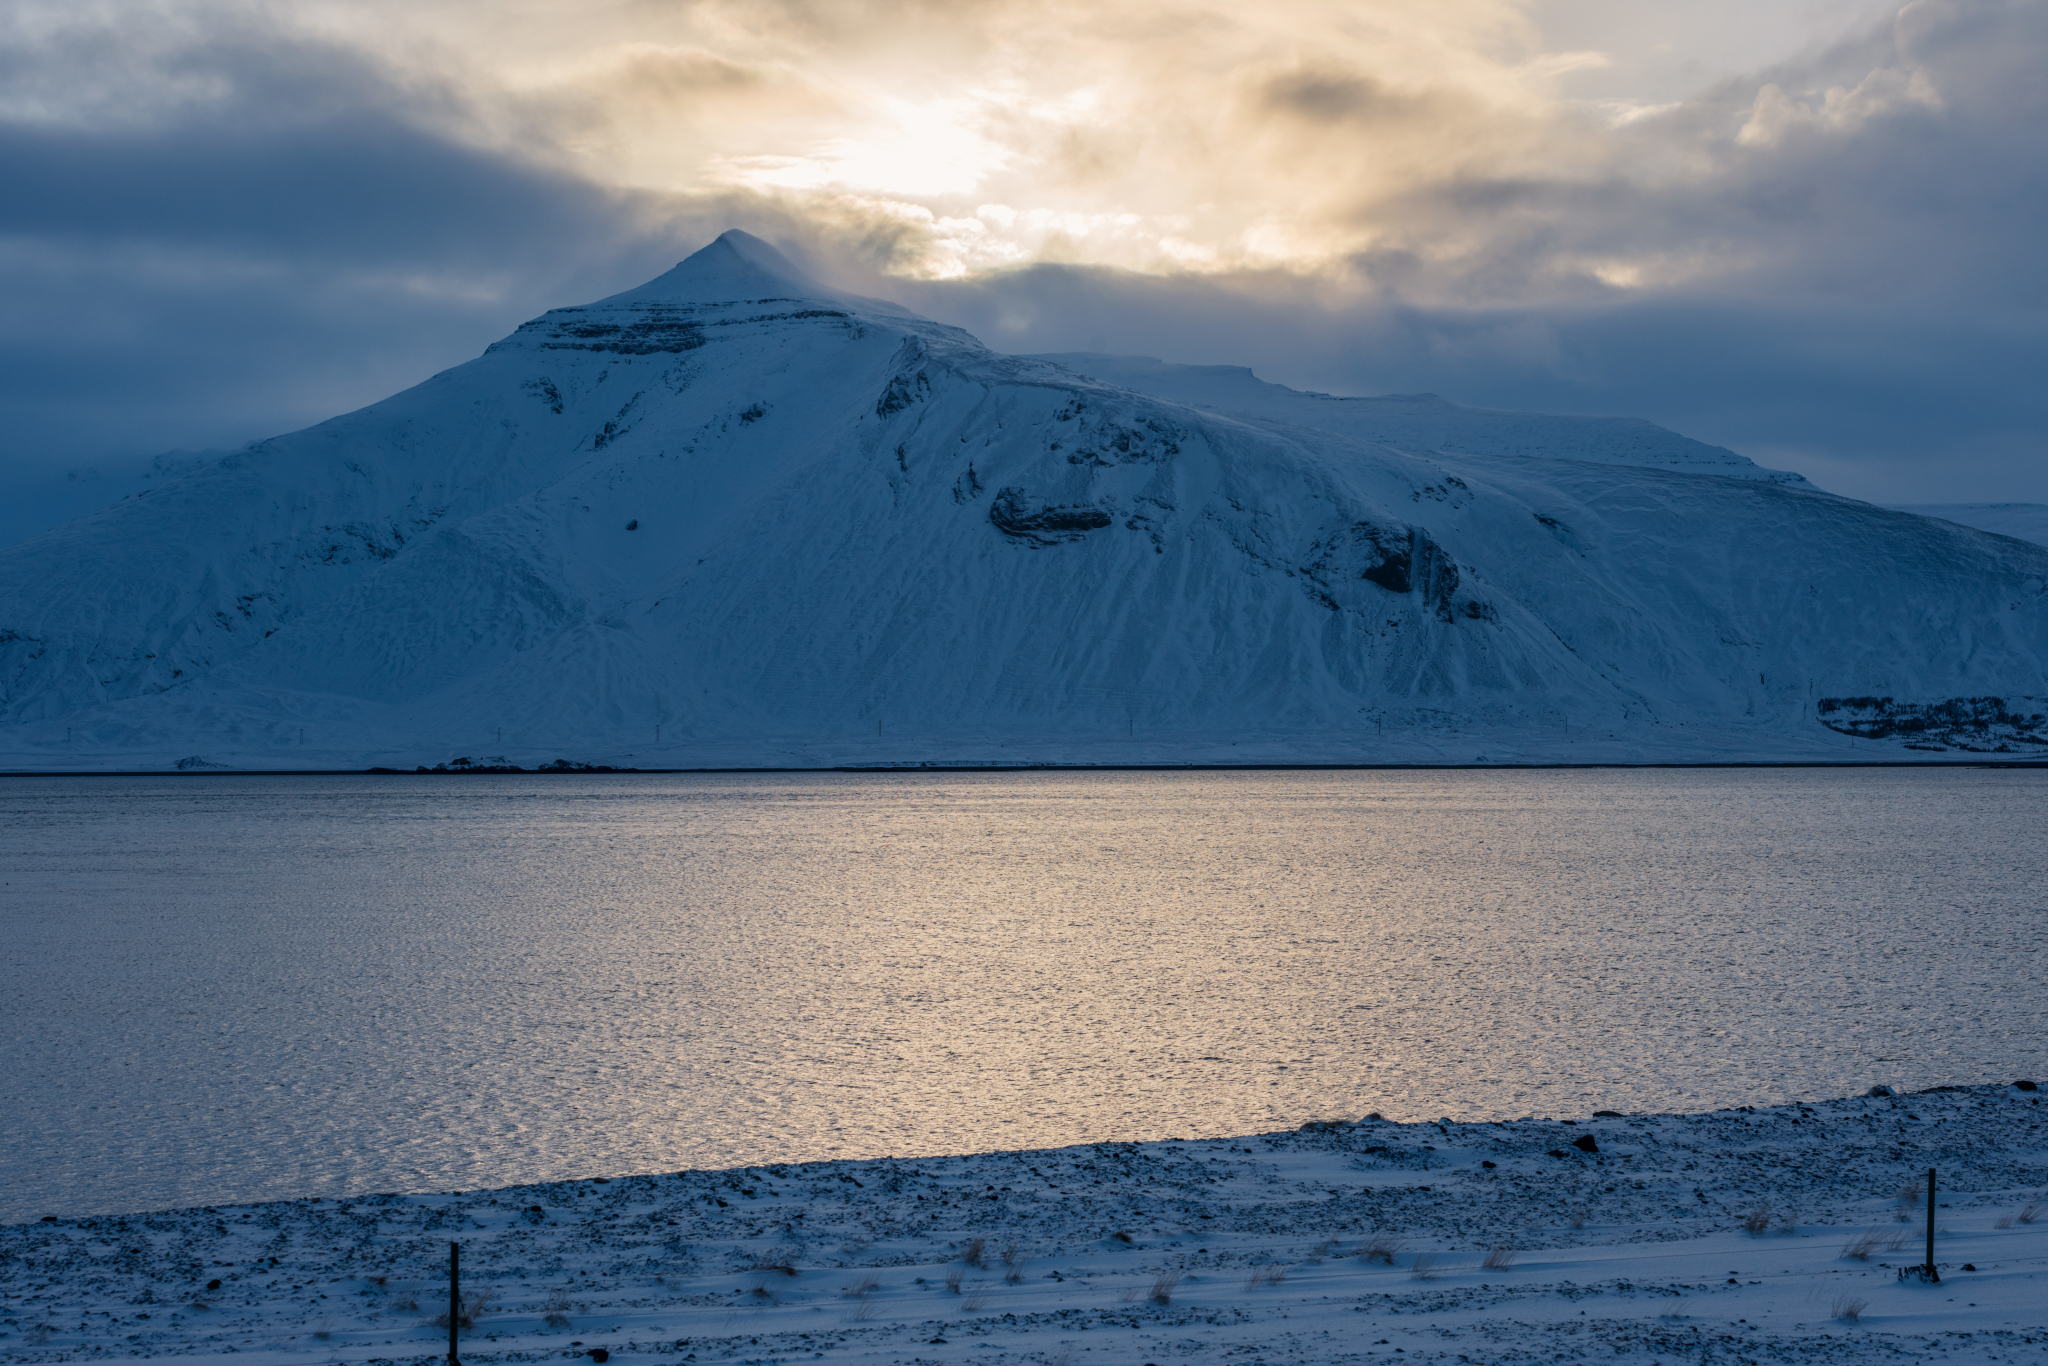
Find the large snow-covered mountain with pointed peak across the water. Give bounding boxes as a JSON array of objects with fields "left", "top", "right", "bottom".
[{"left": 0, "top": 233, "right": 2048, "bottom": 768}]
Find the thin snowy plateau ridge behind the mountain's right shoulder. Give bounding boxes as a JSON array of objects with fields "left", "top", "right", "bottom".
[{"left": 1036, "top": 352, "right": 1810, "bottom": 485}]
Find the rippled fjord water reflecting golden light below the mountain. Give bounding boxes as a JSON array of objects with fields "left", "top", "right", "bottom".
[{"left": 0, "top": 770, "right": 2048, "bottom": 1223}]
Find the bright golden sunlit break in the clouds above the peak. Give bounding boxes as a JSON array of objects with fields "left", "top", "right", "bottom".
[{"left": 247, "top": 0, "right": 1604, "bottom": 276}]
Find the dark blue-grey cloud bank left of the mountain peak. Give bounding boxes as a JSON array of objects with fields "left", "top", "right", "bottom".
[{"left": 0, "top": 16, "right": 704, "bottom": 491}]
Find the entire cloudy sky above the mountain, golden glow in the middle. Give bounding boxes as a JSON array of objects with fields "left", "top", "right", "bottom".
[{"left": 0, "top": 0, "right": 2048, "bottom": 541}]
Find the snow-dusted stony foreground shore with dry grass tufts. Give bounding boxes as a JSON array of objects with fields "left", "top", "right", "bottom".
[{"left": 0, "top": 1085, "right": 2048, "bottom": 1366}]
